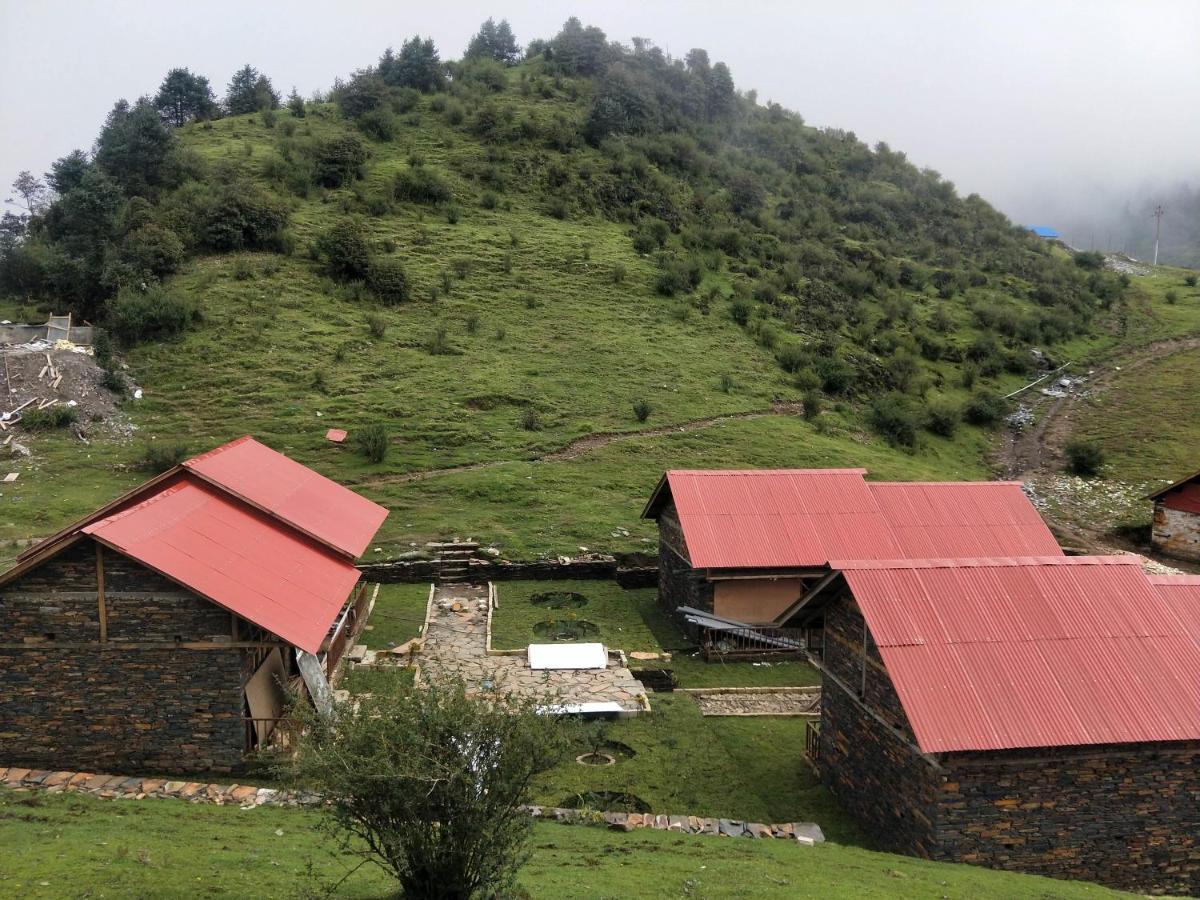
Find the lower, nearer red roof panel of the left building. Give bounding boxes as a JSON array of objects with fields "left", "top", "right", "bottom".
[{"left": 83, "top": 481, "right": 359, "bottom": 653}]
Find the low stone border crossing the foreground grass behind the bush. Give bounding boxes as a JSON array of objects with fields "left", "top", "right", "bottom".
[{"left": 0, "top": 767, "right": 824, "bottom": 846}]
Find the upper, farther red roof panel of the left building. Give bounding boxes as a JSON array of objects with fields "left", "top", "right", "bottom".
[{"left": 184, "top": 436, "right": 388, "bottom": 558}]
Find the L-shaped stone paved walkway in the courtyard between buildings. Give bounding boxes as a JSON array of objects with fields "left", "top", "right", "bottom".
[{"left": 420, "top": 583, "right": 649, "bottom": 714}]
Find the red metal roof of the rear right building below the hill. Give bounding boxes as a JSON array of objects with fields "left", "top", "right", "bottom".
[{"left": 643, "top": 469, "right": 1062, "bottom": 569}]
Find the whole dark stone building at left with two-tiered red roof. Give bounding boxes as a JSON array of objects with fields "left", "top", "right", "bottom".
[{"left": 0, "top": 438, "right": 386, "bottom": 772}]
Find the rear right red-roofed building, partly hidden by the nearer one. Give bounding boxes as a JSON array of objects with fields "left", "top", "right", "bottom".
[{"left": 642, "top": 469, "right": 1062, "bottom": 625}]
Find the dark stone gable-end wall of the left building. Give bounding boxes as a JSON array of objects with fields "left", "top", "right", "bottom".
[{"left": 0, "top": 540, "right": 250, "bottom": 772}]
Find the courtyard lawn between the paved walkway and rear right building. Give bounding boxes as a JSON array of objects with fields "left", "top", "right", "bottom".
[{"left": 492, "top": 580, "right": 821, "bottom": 688}]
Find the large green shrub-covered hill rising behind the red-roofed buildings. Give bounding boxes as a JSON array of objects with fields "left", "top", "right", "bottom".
[{"left": 0, "top": 21, "right": 1185, "bottom": 558}]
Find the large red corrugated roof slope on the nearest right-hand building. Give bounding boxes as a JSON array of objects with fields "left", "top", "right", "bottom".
[{"left": 830, "top": 557, "right": 1200, "bottom": 752}]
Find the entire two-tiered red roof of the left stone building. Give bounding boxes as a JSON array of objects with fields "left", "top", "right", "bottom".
[{"left": 0, "top": 437, "right": 388, "bottom": 653}]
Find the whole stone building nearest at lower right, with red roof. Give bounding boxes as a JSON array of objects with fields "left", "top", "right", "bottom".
[{"left": 798, "top": 557, "right": 1200, "bottom": 894}]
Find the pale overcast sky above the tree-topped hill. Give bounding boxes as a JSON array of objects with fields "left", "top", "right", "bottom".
[{"left": 0, "top": 0, "right": 1200, "bottom": 222}]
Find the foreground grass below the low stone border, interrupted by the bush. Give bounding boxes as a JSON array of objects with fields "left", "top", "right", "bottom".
[{"left": 0, "top": 790, "right": 1123, "bottom": 900}]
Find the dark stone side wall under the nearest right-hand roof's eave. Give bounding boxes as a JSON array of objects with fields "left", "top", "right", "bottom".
[{"left": 935, "top": 742, "right": 1200, "bottom": 895}]
